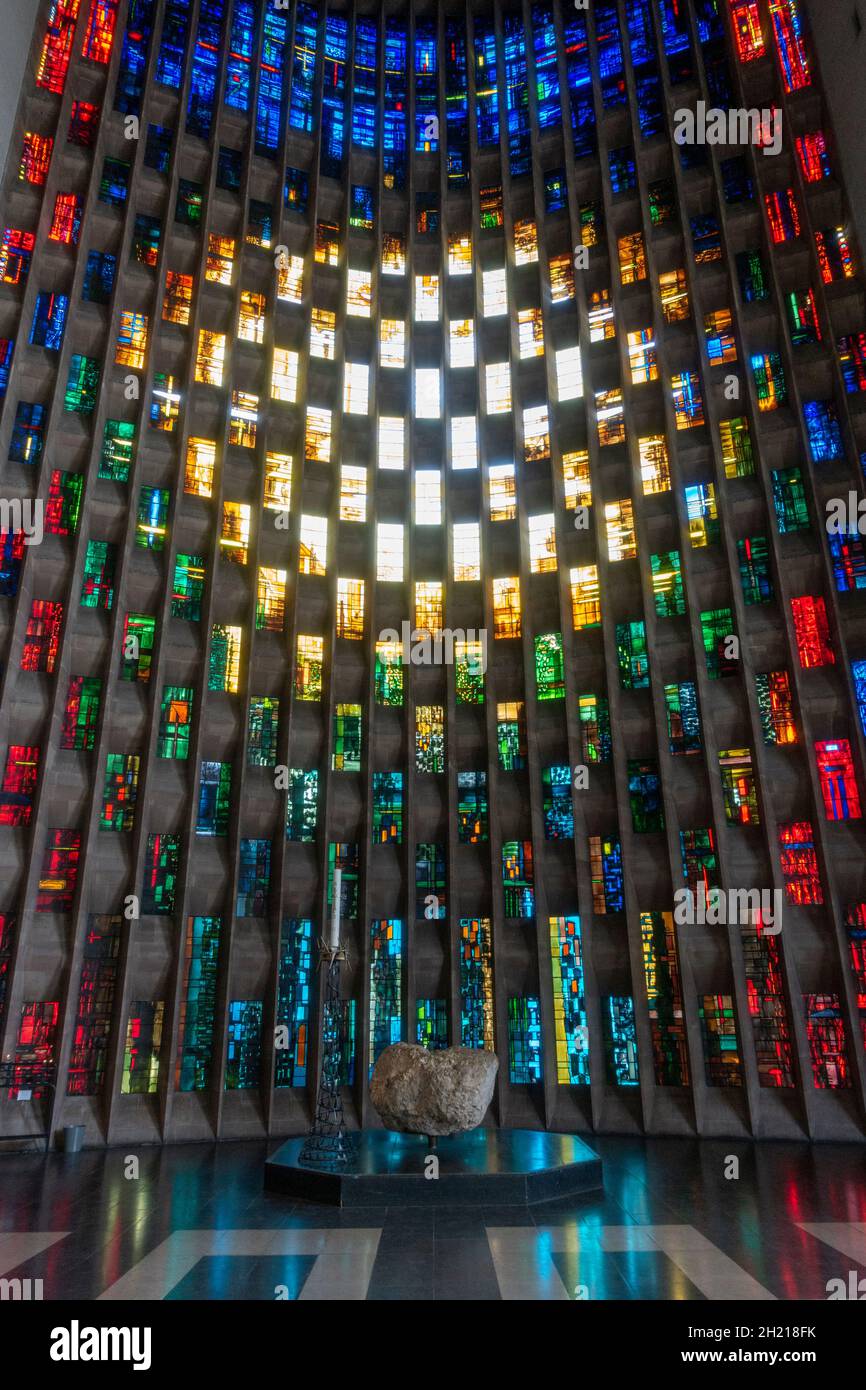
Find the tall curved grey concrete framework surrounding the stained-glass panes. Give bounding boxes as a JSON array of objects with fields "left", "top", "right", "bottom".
[{"left": 0, "top": 0, "right": 866, "bottom": 1143}]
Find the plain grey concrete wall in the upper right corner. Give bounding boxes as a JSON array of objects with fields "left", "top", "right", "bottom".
[{"left": 806, "top": 0, "right": 866, "bottom": 246}]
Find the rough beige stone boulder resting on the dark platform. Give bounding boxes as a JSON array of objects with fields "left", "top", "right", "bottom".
[{"left": 370, "top": 1043, "right": 499, "bottom": 1134}]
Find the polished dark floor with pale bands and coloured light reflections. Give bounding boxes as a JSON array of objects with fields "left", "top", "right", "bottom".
[{"left": 0, "top": 1138, "right": 866, "bottom": 1300}]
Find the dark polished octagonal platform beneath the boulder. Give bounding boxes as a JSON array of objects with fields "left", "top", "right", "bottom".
[{"left": 264, "top": 1129, "right": 602, "bottom": 1207}]
